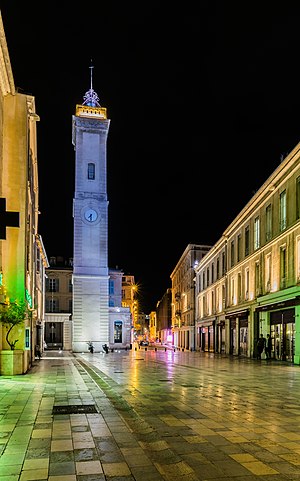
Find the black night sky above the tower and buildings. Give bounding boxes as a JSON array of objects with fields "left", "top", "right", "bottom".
[{"left": 0, "top": 0, "right": 300, "bottom": 313}]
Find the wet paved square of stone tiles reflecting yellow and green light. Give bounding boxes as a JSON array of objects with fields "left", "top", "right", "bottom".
[{"left": 0, "top": 348, "right": 300, "bottom": 481}]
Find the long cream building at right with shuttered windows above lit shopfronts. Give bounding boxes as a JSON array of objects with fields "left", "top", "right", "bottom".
[{"left": 195, "top": 144, "right": 300, "bottom": 364}]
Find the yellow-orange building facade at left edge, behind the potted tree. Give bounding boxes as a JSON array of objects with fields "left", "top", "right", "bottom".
[{"left": 0, "top": 10, "right": 48, "bottom": 374}]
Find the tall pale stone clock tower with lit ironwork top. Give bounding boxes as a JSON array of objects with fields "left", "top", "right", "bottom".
[{"left": 72, "top": 67, "right": 110, "bottom": 352}]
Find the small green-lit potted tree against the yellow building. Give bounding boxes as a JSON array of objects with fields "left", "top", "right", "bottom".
[{"left": 0, "top": 301, "right": 28, "bottom": 351}]
